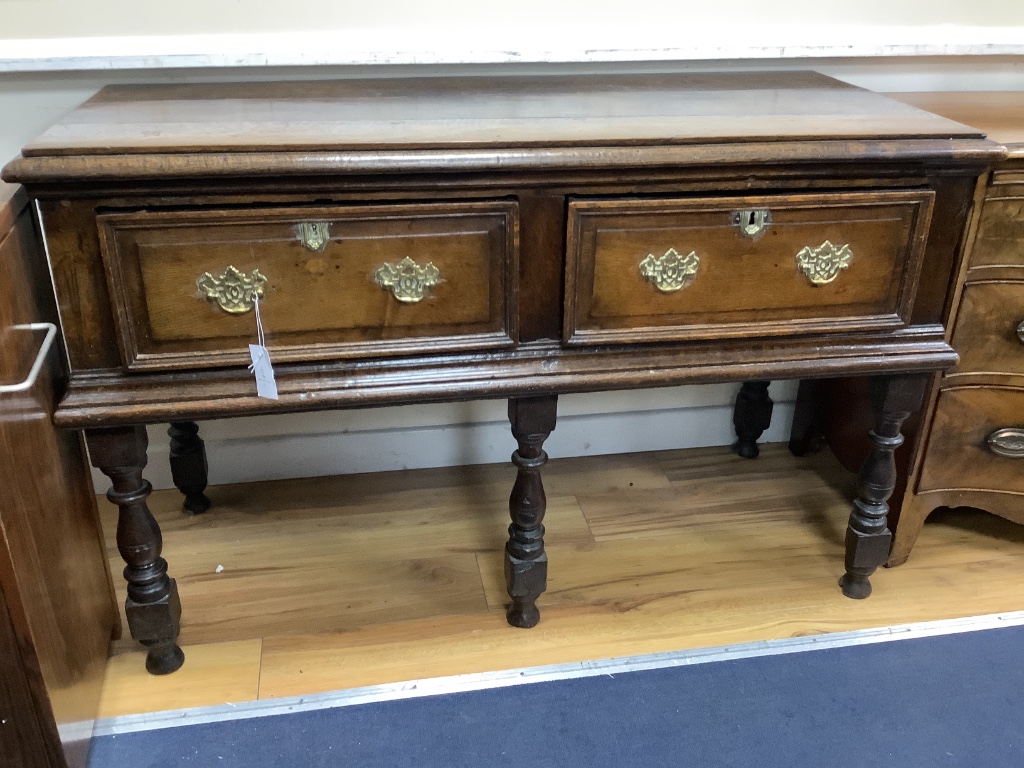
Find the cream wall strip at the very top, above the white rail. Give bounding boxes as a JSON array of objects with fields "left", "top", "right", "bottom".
[{"left": 6, "top": 0, "right": 1024, "bottom": 39}]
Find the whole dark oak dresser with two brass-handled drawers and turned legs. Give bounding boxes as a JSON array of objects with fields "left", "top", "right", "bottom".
[{"left": 5, "top": 73, "right": 1002, "bottom": 672}]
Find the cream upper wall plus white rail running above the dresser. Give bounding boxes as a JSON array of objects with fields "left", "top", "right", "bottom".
[{"left": 0, "top": 0, "right": 1024, "bottom": 71}]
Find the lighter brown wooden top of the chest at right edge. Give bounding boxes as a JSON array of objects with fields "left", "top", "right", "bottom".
[{"left": 888, "top": 91, "right": 1024, "bottom": 159}]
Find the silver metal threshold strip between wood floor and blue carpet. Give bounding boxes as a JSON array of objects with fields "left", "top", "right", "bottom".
[{"left": 86, "top": 610, "right": 1024, "bottom": 736}]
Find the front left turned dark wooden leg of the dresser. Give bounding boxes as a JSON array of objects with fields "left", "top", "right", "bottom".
[{"left": 85, "top": 427, "right": 185, "bottom": 675}]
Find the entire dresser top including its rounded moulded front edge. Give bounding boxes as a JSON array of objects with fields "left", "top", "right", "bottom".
[{"left": 3, "top": 72, "right": 1005, "bottom": 191}]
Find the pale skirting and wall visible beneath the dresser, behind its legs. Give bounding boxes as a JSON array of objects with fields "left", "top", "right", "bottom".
[{"left": 93, "top": 382, "right": 796, "bottom": 490}]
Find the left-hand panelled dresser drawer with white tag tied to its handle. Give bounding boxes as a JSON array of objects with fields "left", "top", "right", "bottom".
[{"left": 98, "top": 201, "right": 518, "bottom": 370}]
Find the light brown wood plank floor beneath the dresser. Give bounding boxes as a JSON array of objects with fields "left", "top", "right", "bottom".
[{"left": 101, "top": 445, "right": 1024, "bottom": 716}]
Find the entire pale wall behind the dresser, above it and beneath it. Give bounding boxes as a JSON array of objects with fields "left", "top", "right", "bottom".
[{"left": 0, "top": 0, "right": 1024, "bottom": 487}]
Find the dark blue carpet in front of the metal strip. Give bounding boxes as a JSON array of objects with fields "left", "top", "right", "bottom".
[{"left": 89, "top": 627, "right": 1024, "bottom": 768}]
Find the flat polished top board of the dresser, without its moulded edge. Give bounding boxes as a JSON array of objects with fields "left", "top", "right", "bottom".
[{"left": 24, "top": 72, "right": 979, "bottom": 157}]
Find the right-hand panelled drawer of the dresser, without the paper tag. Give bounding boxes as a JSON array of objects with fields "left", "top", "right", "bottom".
[{"left": 564, "top": 190, "right": 934, "bottom": 344}]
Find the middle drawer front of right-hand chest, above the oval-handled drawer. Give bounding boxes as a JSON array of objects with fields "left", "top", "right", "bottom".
[{"left": 952, "top": 282, "right": 1024, "bottom": 376}]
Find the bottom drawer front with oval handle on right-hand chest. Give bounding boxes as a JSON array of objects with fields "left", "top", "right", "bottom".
[{"left": 919, "top": 387, "right": 1024, "bottom": 495}]
